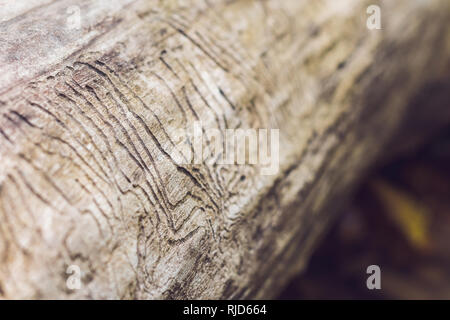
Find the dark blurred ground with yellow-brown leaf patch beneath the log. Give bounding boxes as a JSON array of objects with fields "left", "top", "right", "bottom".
[{"left": 279, "top": 126, "right": 450, "bottom": 299}]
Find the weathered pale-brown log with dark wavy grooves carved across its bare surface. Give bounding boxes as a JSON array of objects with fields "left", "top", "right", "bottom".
[{"left": 0, "top": 0, "right": 450, "bottom": 299}]
